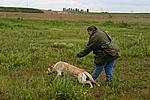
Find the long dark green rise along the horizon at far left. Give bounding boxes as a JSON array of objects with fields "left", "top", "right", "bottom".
[{"left": 0, "top": 7, "right": 43, "bottom": 13}]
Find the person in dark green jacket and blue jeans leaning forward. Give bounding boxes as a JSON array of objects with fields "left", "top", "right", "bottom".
[{"left": 77, "top": 25, "right": 119, "bottom": 84}]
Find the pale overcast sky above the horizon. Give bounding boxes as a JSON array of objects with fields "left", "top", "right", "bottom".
[{"left": 0, "top": 0, "right": 150, "bottom": 13}]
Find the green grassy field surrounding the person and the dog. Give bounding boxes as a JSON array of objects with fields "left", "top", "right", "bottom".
[{"left": 0, "top": 14, "right": 150, "bottom": 100}]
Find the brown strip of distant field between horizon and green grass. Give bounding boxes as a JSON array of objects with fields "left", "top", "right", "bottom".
[{"left": 0, "top": 10, "right": 150, "bottom": 24}]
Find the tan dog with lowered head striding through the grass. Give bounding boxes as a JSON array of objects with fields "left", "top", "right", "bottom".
[{"left": 48, "top": 61, "right": 99, "bottom": 88}]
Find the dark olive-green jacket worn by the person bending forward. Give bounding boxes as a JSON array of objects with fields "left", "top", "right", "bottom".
[{"left": 77, "top": 31, "right": 119, "bottom": 64}]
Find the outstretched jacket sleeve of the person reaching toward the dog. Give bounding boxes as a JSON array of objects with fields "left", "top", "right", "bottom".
[{"left": 77, "top": 37, "right": 96, "bottom": 58}]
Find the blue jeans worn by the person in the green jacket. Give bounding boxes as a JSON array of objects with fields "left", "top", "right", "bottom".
[{"left": 92, "top": 60, "right": 115, "bottom": 81}]
